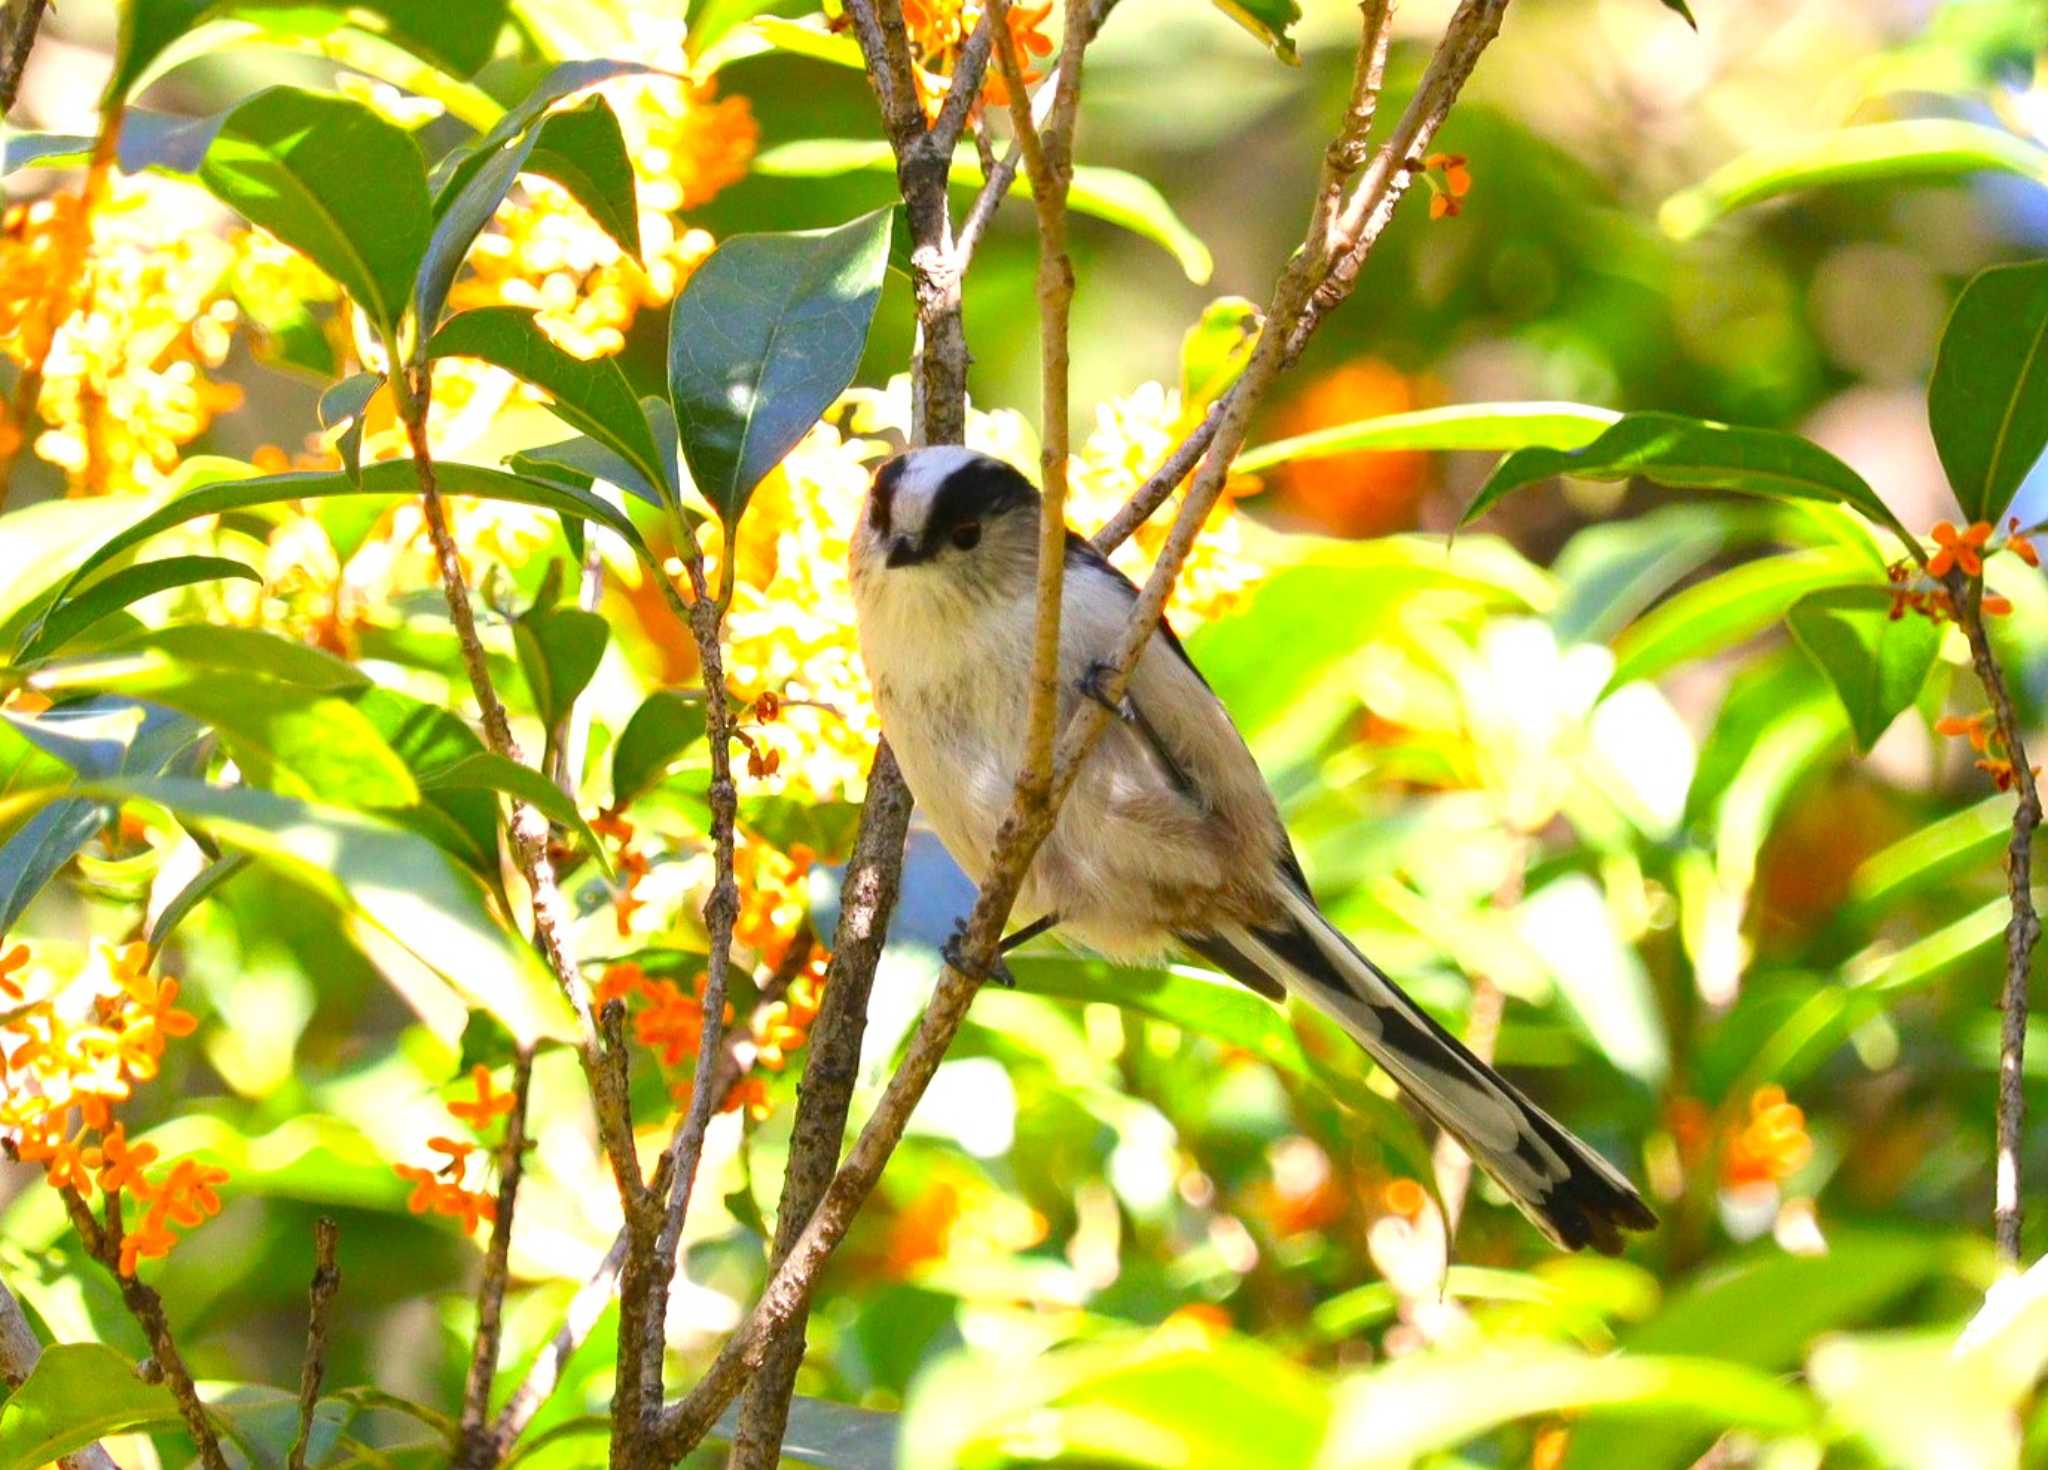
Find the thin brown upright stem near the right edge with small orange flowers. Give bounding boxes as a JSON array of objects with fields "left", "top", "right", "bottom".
[{"left": 1946, "top": 567, "right": 2042, "bottom": 1269}]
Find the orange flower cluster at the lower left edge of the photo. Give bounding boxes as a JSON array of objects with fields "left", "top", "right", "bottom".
[{"left": 0, "top": 944, "right": 227, "bottom": 1276}]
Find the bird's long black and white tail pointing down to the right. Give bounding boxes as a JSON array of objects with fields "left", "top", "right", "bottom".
[{"left": 1182, "top": 884, "right": 1657, "bottom": 1255}]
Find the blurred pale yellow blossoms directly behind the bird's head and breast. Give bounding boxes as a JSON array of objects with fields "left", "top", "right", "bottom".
[{"left": 727, "top": 383, "right": 1266, "bottom": 801}]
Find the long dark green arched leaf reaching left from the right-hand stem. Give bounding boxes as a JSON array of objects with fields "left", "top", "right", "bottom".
[{"left": 1458, "top": 414, "right": 1913, "bottom": 543}]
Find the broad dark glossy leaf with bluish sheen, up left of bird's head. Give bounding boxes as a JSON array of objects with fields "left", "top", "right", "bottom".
[{"left": 668, "top": 209, "right": 889, "bottom": 530}]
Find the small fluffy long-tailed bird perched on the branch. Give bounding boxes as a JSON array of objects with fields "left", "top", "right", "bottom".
[{"left": 848, "top": 446, "right": 1657, "bottom": 1255}]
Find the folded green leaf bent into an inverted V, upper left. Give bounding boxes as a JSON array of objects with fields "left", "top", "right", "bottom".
[{"left": 428, "top": 89, "right": 647, "bottom": 338}]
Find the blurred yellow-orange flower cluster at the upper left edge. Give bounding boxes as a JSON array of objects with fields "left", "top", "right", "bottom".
[{"left": 0, "top": 174, "right": 242, "bottom": 493}]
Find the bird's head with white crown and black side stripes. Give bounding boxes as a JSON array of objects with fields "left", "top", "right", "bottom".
[{"left": 854, "top": 444, "right": 1038, "bottom": 586}]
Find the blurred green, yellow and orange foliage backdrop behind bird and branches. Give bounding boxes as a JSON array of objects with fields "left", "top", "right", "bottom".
[{"left": 0, "top": 0, "right": 2048, "bottom": 1470}]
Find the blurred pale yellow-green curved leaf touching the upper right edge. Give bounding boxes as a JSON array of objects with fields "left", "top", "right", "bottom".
[{"left": 1657, "top": 117, "right": 2048, "bottom": 240}]
